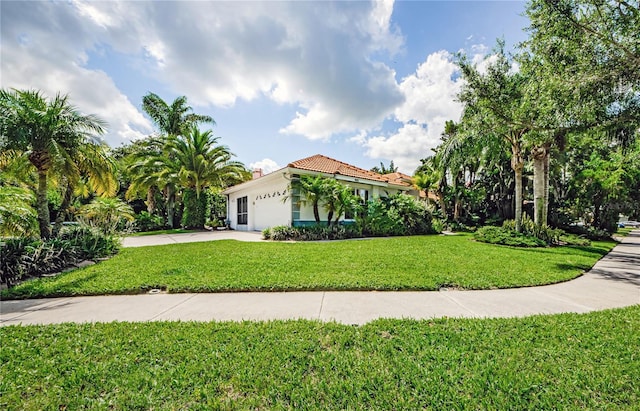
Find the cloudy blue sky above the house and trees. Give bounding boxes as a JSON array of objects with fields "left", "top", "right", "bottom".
[{"left": 0, "top": 0, "right": 527, "bottom": 174}]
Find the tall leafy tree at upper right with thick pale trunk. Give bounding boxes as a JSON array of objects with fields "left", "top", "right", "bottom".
[{"left": 521, "top": 0, "right": 640, "bottom": 225}]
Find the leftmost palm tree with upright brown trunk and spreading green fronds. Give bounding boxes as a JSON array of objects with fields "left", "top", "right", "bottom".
[{"left": 0, "top": 89, "right": 109, "bottom": 238}]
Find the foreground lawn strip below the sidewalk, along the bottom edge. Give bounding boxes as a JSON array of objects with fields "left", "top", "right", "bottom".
[{"left": 0, "top": 306, "right": 640, "bottom": 410}]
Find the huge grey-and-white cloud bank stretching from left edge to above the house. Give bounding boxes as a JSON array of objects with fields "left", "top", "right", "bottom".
[{"left": 2, "top": 0, "right": 404, "bottom": 146}]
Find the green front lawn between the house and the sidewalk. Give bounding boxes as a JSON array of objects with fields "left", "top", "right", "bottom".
[{"left": 2, "top": 235, "right": 615, "bottom": 298}]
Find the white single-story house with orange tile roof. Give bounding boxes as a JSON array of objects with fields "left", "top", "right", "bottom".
[{"left": 222, "top": 154, "right": 419, "bottom": 231}]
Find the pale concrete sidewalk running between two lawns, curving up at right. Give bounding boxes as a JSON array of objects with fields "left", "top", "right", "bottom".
[{"left": 0, "top": 230, "right": 640, "bottom": 325}]
